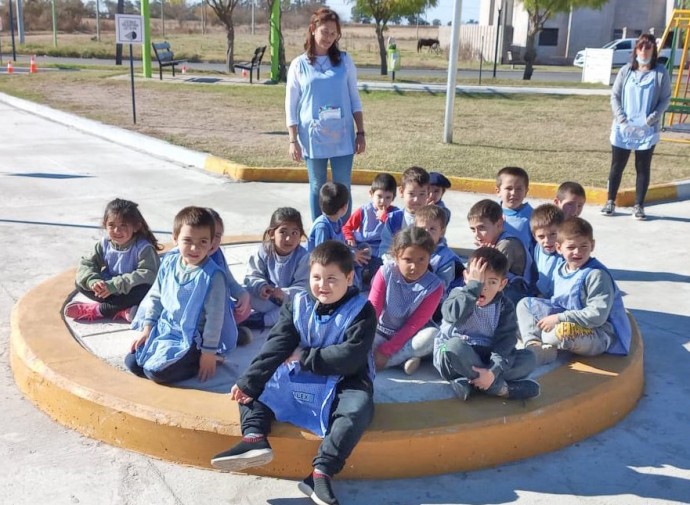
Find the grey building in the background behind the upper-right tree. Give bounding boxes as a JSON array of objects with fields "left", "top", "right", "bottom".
[{"left": 479, "top": 0, "right": 684, "bottom": 63}]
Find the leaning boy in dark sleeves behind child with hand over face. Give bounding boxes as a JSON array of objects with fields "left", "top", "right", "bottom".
[{"left": 467, "top": 199, "right": 534, "bottom": 304}]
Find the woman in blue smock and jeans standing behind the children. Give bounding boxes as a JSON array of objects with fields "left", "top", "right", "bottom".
[{"left": 285, "top": 8, "right": 366, "bottom": 221}]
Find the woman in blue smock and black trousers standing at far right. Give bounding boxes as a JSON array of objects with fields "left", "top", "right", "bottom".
[{"left": 601, "top": 33, "right": 671, "bottom": 220}]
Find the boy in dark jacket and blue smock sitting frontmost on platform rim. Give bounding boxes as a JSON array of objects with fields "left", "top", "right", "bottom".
[{"left": 211, "top": 241, "right": 376, "bottom": 504}]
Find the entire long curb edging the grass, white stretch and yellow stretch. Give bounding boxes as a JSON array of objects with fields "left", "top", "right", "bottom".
[{"left": 0, "top": 91, "right": 690, "bottom": 207}]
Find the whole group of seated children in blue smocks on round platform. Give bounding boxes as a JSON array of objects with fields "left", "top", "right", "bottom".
[{"left": 66, "top": 166, "right": 631, "bottom": 504}]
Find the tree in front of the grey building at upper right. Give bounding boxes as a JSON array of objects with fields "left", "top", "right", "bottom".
[{"left": 520, "top": 0, "right": 608, "bottom": 81}]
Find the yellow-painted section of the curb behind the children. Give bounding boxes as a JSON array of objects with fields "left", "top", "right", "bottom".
[{"left": 204, "top": 155, "right": 678, "bottom": 207}]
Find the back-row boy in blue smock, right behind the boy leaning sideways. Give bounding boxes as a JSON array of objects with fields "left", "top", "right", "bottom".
[{"left": 496, "top": 167, "right": 534, "bottom": 251}]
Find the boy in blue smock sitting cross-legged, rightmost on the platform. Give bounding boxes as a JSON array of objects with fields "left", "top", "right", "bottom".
[{"left": 516, "top": 217, "right": 632, "bottom": 364}]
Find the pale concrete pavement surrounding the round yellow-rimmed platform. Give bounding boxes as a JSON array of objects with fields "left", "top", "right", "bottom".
[{"left": 0, "top": 96, "right": 690, "bottom": 505}]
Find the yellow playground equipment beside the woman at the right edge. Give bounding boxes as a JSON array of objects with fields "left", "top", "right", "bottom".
[{"left": 660, "top": 9, "right": 690, "bottom": 144}]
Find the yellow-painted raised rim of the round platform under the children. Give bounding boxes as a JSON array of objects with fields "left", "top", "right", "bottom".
[{"left": 10, "top": 237, "right": 644, "bottom": 479}]
